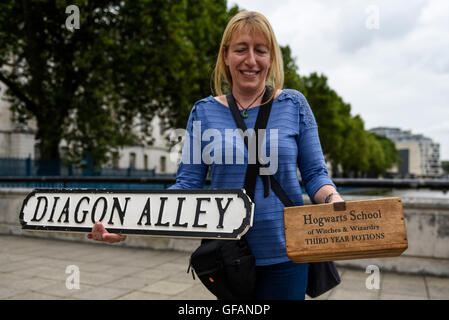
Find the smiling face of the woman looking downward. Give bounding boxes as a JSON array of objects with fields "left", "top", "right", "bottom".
[{"left": 224, "top": 27, "right": 271, "bottom": 94}]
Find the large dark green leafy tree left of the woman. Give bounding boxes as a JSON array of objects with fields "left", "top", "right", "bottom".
[{"left": 0, "top": 0, "right": 231, "bottom": 170}]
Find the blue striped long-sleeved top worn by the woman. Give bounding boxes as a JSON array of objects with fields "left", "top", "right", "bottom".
[{"left": 170, "top": 89, "right": 335, "bottom": 266}]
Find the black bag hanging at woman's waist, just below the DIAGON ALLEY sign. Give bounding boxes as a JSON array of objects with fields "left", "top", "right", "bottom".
[{"left": 190, "top": 237, "right": 256, "bottom": 300}]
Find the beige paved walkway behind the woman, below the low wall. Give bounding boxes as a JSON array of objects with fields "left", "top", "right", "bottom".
[{"left": 0, "top": 235, "right": 449, "bottom": 300}]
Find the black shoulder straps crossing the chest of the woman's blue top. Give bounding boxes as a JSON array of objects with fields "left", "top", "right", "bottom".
[{"left": 226, "top": 86, "right": 293, "bottom": 207}]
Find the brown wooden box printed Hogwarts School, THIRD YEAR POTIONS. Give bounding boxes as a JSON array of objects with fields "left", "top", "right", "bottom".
[{"left": 284, "top": 198, "right": 408, "bottom": 262}]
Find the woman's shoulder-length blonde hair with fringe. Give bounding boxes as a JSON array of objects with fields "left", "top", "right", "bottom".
[{"left": 213, "top": 11, "right": 284, "bottom": 97}]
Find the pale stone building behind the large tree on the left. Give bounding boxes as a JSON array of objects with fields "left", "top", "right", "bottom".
[{"left": 0, "top": 82, "right": 180, "bottom": 174}]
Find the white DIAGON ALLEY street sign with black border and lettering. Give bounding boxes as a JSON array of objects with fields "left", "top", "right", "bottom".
[{"left": 20, "top": 189, "right": 254, "bottom": 239}]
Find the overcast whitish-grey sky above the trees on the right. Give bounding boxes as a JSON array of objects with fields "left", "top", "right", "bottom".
[{"left": 228, "top": 0, "right": 449, "bottom": 160}]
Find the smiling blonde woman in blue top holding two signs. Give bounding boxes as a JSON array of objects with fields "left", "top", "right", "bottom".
[{"left": 89, "top": 11, "right": 342, "bottom": 299}]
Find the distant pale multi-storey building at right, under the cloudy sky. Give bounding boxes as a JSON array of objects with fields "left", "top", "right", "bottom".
[{"left": 369, "top": 127, "right": 442, "bottom": 178}]
